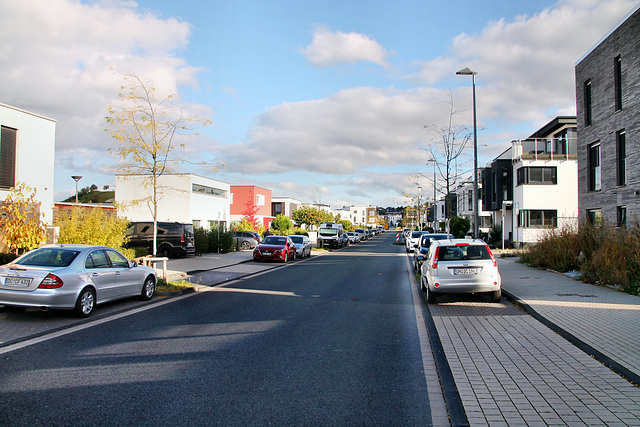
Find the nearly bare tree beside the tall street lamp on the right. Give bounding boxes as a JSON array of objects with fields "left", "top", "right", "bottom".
[{"left": 420, "top": 92, "right": 473, "bottom": 221}]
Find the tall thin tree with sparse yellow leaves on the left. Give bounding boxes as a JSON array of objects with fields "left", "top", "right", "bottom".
[{"left": 106, "top": 74, "right": 217, "bottom": 255}]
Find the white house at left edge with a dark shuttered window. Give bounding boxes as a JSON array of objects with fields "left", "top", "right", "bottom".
[{"left": 0, "top": 104, "right": 56, "bottom": 225}]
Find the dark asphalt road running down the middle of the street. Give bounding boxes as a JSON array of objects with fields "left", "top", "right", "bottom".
[{"left": 0, "top": 233, "right": 437, "bottom": 426}]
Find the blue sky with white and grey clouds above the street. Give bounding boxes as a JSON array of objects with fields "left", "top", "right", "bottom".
[{"left": 0, "top": 0, "right": 637, "bottom": 208}]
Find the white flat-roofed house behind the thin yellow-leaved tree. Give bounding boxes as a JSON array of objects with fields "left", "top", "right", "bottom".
[{"left": 115, "top": 174, "right": 231, "bottom": 229}]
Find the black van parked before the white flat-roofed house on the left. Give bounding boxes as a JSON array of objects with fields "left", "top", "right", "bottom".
[{"left": 125, "top": 222, "right": 196, "bottom": 258}]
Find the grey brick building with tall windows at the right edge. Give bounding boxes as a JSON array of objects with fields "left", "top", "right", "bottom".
[{"left": 575, "top": 4, "right": 640, "bottom": 226}]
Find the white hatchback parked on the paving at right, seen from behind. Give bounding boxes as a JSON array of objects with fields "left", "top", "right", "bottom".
[{"left": 420, "top": 239, "right": 502, "bottom": 304}]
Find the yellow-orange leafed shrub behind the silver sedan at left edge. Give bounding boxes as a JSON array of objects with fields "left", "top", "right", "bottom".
[{"left": 0, "top": 182, "right": 47, "bottom": 255}]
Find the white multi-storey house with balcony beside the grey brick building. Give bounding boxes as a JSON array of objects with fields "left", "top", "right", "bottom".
[{"left": 482, "top": 116, "right": 578, "bottom": 243}]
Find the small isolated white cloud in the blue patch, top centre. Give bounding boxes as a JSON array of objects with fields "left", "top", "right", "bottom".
[{"left": 300, "top": 25, "right": 390, "bottom": 67}]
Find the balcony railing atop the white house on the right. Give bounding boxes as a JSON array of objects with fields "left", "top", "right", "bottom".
[{"left": 511, "top": 138, "right": 578, "bottom": 162}]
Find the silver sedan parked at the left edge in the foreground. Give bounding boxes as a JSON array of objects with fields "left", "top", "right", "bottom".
[{"left": 0, "top": 244, "right": 157, "bottom": 317}]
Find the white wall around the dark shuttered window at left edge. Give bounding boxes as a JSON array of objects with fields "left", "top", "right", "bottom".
[{"left": 0, "top": 104, "right": 56, "bottom": 225}]
